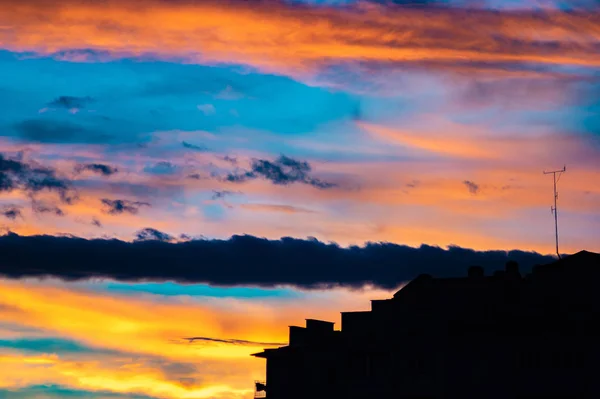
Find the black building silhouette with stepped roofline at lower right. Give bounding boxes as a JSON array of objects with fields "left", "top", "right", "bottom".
[{"left": 253, "top": 251, "right": 600, "bottom": 399}]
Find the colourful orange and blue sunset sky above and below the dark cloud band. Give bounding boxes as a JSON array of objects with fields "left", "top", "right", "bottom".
[{"left": 0, "top": 0, "right": 600, "bottom": 399}]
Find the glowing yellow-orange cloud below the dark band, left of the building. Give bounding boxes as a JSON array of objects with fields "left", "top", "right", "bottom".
[{"left": 0, "top": 280, "right": 389, "bottom": 399}]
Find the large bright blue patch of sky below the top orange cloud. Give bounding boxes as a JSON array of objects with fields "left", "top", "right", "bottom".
[{"left": 0, "top": 52, "right": 357, "bottom": 148}]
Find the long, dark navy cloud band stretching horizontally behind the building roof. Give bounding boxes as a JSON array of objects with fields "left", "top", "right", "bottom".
[{"left": 0, "top": 233, "right": 554, "bottom": 288}]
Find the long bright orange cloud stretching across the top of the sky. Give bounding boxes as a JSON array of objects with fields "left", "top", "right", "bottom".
[{"left": 0, "top": 0, "right": 600, "bottom": 78}]
